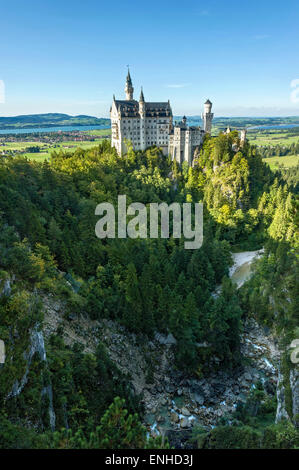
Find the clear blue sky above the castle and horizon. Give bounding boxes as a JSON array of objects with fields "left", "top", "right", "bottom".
[{"left": 0, "top": 0, "right": 299, "bottom": 117}]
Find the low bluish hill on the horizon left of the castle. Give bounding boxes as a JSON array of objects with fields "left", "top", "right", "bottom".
[{"left": 0, "top": 113, "right": 110, "bottom": 129}]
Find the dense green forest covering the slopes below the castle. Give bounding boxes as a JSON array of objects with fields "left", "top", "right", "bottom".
[{"left": 0, "top": 132, "right": 299, "bottom": 448}]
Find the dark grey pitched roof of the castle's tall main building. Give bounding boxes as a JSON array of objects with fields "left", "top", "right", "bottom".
[{"left": 115, "top": 100, "right": 172, "bottom": 117}]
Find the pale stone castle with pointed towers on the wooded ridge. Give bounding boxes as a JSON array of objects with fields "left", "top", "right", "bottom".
[{"left": 110, "top": 70, "right": 214, "bottom": 165}]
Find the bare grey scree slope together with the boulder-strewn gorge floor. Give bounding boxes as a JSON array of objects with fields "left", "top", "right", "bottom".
[{"left": 44, "top": 301, "right": 279, "bottom": 440}]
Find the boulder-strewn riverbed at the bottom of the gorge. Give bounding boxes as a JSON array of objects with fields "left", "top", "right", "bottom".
[{"left": 144, "top": 320, "right": 279, "bottom": 434}]
